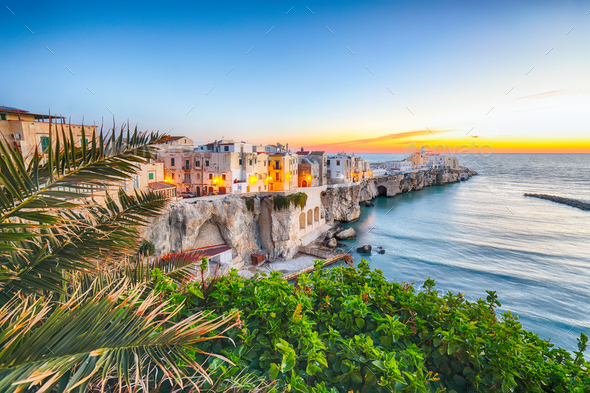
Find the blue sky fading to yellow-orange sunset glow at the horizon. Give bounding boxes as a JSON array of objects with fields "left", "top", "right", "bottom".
[{"left": 0, "top": 0, "right": 590, "bottom": 153}]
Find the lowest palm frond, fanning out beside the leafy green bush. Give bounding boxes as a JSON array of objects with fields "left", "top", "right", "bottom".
[{"left": 0, "top": 280, "right": 237, "bottom": 392}]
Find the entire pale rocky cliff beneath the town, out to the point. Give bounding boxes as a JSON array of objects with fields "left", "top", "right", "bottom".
[{"left": 144, "top": 168, "right": 473, "bottom": 263}]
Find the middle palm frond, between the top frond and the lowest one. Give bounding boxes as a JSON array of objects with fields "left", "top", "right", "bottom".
[{"left": 0, "top": 190, "right": 167, "bottom": 302}]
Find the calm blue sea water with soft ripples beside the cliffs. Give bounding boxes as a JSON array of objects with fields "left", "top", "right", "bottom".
[{"left": 336, "top": 154, "right": 590, "bottom": 350}]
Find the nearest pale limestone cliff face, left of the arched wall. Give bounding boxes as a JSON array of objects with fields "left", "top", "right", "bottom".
[{"left": 145, "top": 195, "right": 301, "bottom": 261}]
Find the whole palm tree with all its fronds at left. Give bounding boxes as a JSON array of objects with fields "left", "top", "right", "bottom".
[{"left": 0, "top": 124, "right": 237, "bottom": 392}]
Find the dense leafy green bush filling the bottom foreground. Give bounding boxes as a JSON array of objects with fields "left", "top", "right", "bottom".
[{"left": 160, "top": 261, "right": 590, "bottom": 393}]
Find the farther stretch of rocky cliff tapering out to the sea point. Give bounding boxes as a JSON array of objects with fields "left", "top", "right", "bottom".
[{"left": 322, "top": 168, "right": 477, "bottom": 221}]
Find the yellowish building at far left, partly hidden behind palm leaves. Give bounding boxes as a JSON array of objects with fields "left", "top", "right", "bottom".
[{"left": 0, "top": 106, "right": 97, "bottom": 160}]
